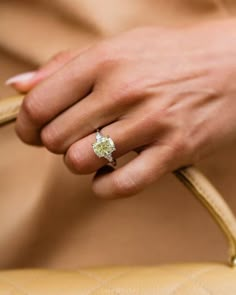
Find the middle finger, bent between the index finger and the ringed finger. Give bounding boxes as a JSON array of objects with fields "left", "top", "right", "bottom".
[{"left": 41, "top": 91, "right": 127, "bottom": 154}]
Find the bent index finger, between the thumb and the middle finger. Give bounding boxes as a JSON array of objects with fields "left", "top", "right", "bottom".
[{"left": 16, "top": 47, "right": 96, "bottom": 144}]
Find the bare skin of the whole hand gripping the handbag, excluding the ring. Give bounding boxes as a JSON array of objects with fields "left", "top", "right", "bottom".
[{"left": 13, "top": 20, "right": 236, "bottom": 198}]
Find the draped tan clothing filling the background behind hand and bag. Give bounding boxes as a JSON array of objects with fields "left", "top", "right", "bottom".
[{"left": 0, "top": 0, "right": 236, "bottom": 268}]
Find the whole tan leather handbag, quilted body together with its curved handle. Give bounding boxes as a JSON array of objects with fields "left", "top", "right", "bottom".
[{"left": 0, "top": 96, "right": 236, "bottom": 295}]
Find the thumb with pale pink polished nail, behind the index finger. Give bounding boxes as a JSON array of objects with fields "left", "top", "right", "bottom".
[{"left": 5, "top": 50, "right": 79, "bottom": 93}]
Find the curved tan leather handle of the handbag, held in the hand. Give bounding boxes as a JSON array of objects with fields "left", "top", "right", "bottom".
[{"left": 0, "top": 96, "right": 236, "bottom": 266}]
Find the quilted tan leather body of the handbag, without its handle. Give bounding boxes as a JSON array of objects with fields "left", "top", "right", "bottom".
[{"left": 0, "top": 264, "right": 236, "bottom": 295}]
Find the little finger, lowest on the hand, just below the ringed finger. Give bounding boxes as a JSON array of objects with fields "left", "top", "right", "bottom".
[{"left": 93, "top": 145, "right": 177, "bottom": 198}]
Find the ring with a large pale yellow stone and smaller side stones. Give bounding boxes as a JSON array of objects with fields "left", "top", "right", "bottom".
[{"left": 92, "top": 130, "right": 116, "bottom": 166}]
